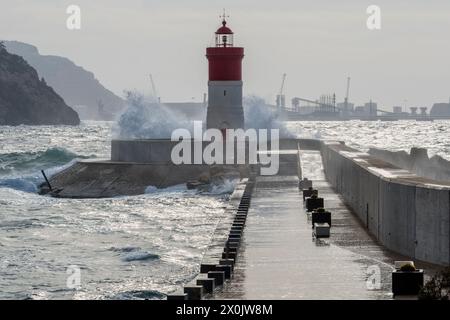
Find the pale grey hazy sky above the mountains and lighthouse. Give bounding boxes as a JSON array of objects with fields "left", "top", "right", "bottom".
[{"left": 0, "top": 0, "right": 450, "bottom": 109}]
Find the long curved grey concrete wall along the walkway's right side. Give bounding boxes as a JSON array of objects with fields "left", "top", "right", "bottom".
[{"left": 321, "top": 142, "right": 450, "bottom": 265}]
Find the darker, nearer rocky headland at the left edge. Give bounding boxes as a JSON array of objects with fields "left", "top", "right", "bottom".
[{"left": 0, "top": 42, "right": 80, "bottom": 125}]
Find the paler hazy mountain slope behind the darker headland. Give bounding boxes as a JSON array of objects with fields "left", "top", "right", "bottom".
[{"left": 5, "top": 41, "right": 125, "bottom": 120}]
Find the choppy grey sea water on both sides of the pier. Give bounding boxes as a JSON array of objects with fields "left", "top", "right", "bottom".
[{"left": 0, "top": 121, "right": 450, "bottom": 299}]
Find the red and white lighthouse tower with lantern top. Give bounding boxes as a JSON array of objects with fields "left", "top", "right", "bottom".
[{"left": 206, "top": 15, "right": 244, "bottom": 130}]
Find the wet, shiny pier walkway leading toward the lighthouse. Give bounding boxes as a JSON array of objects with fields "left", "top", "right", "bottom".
[{"left": 214, "top": 151, "right": 430, "bottom": 299}]
